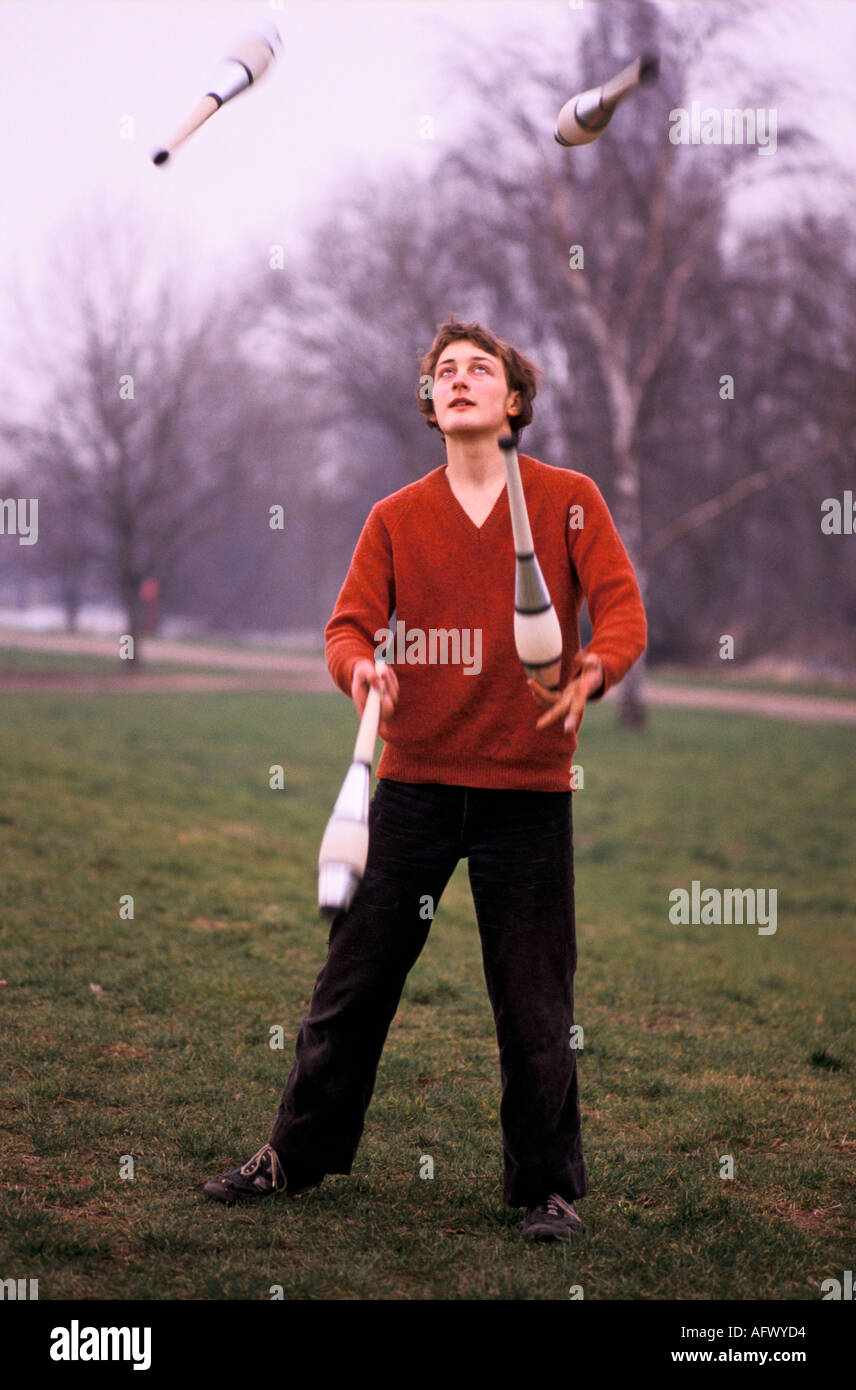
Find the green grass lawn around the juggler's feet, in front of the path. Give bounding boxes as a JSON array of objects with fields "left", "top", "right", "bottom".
[{"left": 0, "top": 692, "right": 856, "bottom": 1301}]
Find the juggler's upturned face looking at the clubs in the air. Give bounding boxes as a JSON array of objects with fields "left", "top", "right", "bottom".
[{"left": 431, "top": 339, "right": 520, "bottom": 439}]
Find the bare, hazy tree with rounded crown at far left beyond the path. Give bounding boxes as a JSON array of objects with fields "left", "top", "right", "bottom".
[{"left": 3, "top": 202, "right": 258, "bottom": 670}]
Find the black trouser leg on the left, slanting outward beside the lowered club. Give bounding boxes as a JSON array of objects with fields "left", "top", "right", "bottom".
[{"left": 271, "top": 778, "right": 464, "bottom": 1187}]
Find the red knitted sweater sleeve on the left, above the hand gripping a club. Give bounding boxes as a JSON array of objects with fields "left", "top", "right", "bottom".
[{"left": 324, "top": 503, "right": 396, "bottom": 696}]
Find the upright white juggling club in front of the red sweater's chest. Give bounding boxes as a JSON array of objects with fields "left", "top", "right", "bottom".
[{"left": 499, "top": 435, "right": 561, "bottom": 691}]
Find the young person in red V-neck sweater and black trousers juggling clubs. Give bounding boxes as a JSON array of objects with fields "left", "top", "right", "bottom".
[{"left": 204, "top": 321, "right": 646, "bottom": 1240}]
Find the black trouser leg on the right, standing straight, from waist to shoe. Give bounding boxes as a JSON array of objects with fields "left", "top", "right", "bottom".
[{"left": 464, "top": 791, "right": 588, "bottom": 1207}]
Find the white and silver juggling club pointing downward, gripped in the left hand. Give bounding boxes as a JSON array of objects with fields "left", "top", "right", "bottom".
[{"left": 318, "top": 660, "right": 385, "bottom": 916}]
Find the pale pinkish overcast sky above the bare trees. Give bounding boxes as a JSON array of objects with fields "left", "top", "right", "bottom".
[{"left": 0, "top": 0, "right": 856, "bottom": 353}]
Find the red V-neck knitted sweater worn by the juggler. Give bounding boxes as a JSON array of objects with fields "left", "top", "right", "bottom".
[{"left": 324, "top": 453, "right": 646, "bottom": 791}]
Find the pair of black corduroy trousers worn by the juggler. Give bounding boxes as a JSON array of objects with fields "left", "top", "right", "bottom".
[{"left": 271, "top": 778, "right": 588, "bottom": 1207}]
